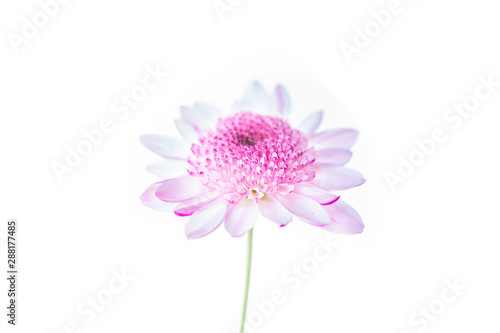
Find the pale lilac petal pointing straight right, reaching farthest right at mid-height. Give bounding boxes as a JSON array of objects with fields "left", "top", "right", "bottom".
[{"left": 312, "top": 163, "right": 365, "bottom": 191}]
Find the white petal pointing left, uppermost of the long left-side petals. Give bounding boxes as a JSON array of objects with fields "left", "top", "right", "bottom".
[{"left": 139, "top": 134, "right": 191, "bottom": 159}]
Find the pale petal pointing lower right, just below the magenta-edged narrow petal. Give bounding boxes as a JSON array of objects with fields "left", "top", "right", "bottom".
[{"left": 276, "top": 192, "right": 330, "bottom": 226}]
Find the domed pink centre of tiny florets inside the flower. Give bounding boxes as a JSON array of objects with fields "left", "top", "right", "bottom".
[{"left": 189, "top": 112, "right": 314, "bottom": 200}]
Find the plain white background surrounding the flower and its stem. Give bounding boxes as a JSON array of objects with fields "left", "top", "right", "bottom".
[{"left": 0, "top": 0, "right": 500, "bottom": 333}]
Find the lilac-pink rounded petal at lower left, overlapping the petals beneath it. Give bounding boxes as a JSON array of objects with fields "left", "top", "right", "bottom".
[{"left": 156, "top": 175, "right": 205, "bottom": 202}]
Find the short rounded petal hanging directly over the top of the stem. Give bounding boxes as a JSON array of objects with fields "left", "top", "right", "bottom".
[{"left": 224, "top": 199, "right": 259, "bottom": 237}]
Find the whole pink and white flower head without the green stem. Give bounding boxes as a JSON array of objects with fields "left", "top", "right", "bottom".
[{"left": 141, "top": 82, "right": 365, "bottom": 239}]
